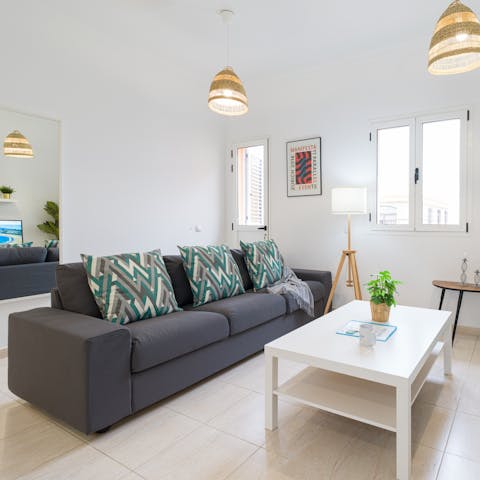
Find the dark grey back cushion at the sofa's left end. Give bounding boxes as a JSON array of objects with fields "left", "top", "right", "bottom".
[{"left": 57, "top": 262, "right": 102, "bottom": 318}]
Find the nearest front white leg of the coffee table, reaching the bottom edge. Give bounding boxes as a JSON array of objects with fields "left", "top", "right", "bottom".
[{"left": 397, "top": 382, "right": 412, "bottom": 480}]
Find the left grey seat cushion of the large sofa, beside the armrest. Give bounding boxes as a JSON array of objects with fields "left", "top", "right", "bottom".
[{"left": 126, "top": 311, "right": 229, "bottom": 372}]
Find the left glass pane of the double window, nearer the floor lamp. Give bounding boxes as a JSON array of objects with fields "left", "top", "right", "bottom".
[{"left": 377, "top": 126, "right": 410, "bottom": 225}]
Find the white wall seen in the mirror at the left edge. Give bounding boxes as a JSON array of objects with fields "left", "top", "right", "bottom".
[{"left": 0, "top": 109, "right": 59, "bottom": 246}]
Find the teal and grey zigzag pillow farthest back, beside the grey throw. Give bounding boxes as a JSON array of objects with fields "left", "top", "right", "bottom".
[{"left": 240, "top": 240, "right": 283, "bottom": 290}]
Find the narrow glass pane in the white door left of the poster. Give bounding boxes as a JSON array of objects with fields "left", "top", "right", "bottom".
[{"left": 237, "top": 145, "right": 265, "bottom": 226}]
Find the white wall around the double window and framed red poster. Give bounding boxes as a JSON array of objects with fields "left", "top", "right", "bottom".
[{"left": 227, "top": 42, "right": 480, "bottom": 327}]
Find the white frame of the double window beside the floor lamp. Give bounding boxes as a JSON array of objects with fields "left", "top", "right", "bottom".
[{"left": 371, "top": 107, "right": 471, "bottom": 233}]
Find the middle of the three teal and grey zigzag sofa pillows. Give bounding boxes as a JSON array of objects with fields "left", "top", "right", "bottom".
[{"left": 178, "top": 245, "right": 245, "bottom": 307}]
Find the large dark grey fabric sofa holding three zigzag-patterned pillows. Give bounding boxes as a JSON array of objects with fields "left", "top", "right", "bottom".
[{"left": 8, "top": 251, "right": 331, "bottom": 434}]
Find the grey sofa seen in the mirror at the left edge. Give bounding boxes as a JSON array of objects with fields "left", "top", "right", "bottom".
[{"left": 0, "top": 247, "right": 59, "bottom": 300}]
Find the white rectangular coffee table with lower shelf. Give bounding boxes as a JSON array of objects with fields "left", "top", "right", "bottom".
[{"left": 265, "top": 300, "right": 452, "bottom": 480}]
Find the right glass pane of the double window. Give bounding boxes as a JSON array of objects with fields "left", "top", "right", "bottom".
[{"left": 422, "top": 119, "right": 461, "bottom": 225}]
